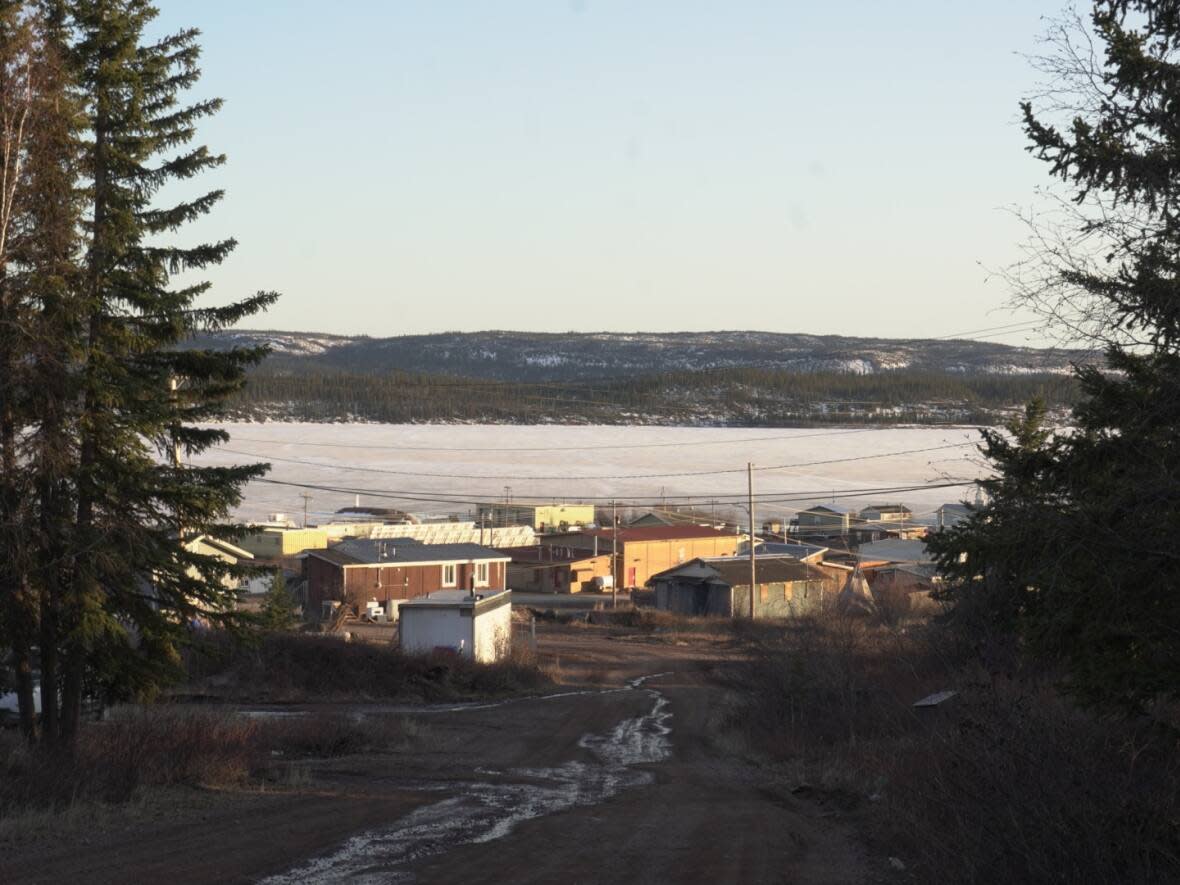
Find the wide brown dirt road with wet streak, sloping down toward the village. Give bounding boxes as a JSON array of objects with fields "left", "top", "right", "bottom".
[{"left": 0, "top": 625, "right": 867, "bottom": 885}]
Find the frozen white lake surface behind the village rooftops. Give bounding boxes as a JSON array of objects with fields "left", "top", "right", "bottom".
[{"left": 195, "top": 422, "right": 988, "bottom": 522}]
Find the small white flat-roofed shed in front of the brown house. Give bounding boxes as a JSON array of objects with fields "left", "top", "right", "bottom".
[{"left": 399, "top": 590, "right": 512, "bottom": 663}]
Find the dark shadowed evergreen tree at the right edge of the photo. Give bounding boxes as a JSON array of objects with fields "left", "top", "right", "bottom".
[{"left": 935, "top": 0, "right": 1180, "bottom": 709}]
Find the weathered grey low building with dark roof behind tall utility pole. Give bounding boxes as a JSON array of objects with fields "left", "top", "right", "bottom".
[{"left": 650, "top": 556, "right": 831, "bottom": 618}]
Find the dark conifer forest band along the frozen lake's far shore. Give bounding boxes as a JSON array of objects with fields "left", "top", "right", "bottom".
[{"left": 228, "top": 366, "right": 1076, "bottom": 426}]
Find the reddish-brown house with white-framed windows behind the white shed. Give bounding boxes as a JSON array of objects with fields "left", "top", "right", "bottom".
[{"left": 303, "top": 538, "right": 510, "bottom": 614}]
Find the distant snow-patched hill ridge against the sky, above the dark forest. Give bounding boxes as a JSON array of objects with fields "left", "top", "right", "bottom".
[{"left": 188, "top": 329, "right": 1086, "bottom": 382}]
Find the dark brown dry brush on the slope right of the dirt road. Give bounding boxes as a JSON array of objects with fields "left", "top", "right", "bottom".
[{"left": 730, "top": 616, "right": 1180, "bottom": 883}]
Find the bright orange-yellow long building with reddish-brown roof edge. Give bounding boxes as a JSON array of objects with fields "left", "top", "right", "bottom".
[{"left": 542, "top": 525, "right": 745, "bottom": 588}]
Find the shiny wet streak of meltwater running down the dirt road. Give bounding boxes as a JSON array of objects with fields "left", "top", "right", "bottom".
[{"left": 261, "top": 674, "right": 671, "bottom": 885}]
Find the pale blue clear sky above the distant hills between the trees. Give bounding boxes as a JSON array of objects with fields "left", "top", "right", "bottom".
[{"left": 158, "top": 0, "right": 1061, "bottom": 343}]
